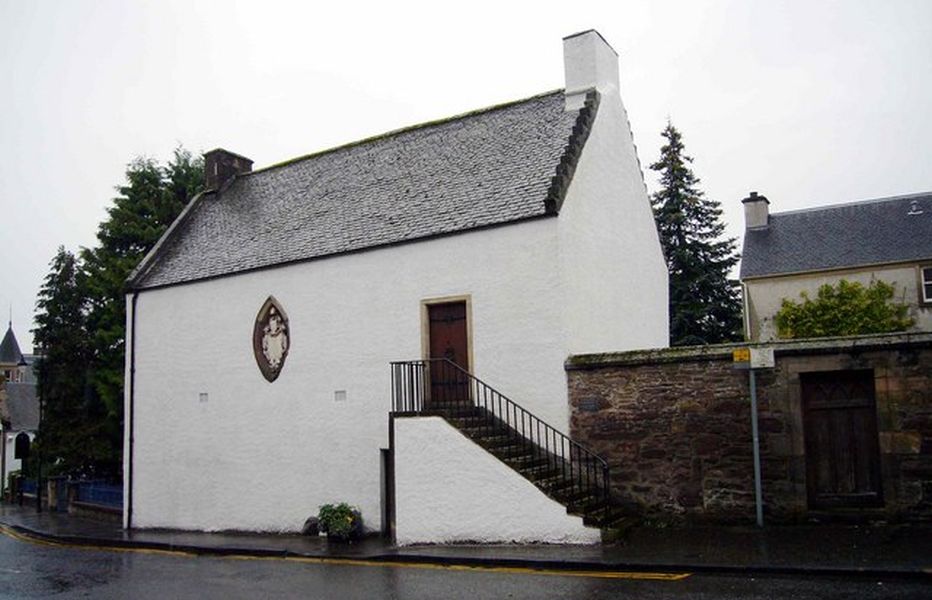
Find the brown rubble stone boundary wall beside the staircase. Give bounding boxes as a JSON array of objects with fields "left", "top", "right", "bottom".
[{"left": 565, "top": 333, "right": 932, "bottom": 522}]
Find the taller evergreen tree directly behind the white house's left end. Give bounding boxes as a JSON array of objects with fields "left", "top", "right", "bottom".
[{"left": 81, "top": 148, "right": 204, "bottom": 472}]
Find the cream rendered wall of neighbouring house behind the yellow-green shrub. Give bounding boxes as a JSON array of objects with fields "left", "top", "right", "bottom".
[{"left": 744, "top": 265, "right": 932, "bottom": 342}]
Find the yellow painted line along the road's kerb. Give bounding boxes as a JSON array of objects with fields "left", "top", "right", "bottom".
[{"left": 0, "top": 524, "right": 692, "bottom": 581}]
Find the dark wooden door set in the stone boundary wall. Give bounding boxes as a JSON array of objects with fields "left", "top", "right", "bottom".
[{"left": 800, "top": 370, "right": 883, "bottom": 508}]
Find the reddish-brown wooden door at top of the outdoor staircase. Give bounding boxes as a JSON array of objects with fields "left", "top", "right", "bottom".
[{"left": 427, "top": 302, "right": 469, "bottom": 405}]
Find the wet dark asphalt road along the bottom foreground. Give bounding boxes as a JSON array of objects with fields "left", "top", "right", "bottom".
[{"left": 0, "top": 535, "right": 932, "bottom": 600}]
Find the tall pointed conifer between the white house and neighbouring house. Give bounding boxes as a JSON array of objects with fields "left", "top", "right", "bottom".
[{"left": 650, "top": 122, "right": 742, "bottom": 346}]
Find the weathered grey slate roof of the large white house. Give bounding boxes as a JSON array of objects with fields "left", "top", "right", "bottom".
[{"left": 129, "top": 90, "right": 598, "bottom": 289}]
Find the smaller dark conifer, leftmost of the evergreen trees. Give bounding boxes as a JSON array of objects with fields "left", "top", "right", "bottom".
[{"left": 33, "top": 247, "right": 100, "bottom": 473}]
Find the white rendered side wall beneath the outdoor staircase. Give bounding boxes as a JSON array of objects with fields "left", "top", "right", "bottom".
[{"left": 394, "top": 417, "right": 600, "bottom": 545}]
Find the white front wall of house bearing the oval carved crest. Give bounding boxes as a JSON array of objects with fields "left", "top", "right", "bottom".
[{"left": 127, "top": 218, "right": 568, "bottom": 531}]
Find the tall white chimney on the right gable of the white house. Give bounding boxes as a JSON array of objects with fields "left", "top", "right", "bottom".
[{"left": 563, "top": 29, "right": 619, "bottom": 110}]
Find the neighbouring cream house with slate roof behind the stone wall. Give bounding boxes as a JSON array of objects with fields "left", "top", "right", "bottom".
[{"left": 741, "top": 192, "right": 932, "bottom": 342}]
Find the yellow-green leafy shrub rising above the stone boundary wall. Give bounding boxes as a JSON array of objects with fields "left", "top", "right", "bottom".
[{"left": 775, "top": 279, "right": 915, "bottom": 338}]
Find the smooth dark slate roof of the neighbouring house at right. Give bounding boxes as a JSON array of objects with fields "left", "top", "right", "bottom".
[{"left": 741, "top": 192, "right": 932, "bottom": 279}]
